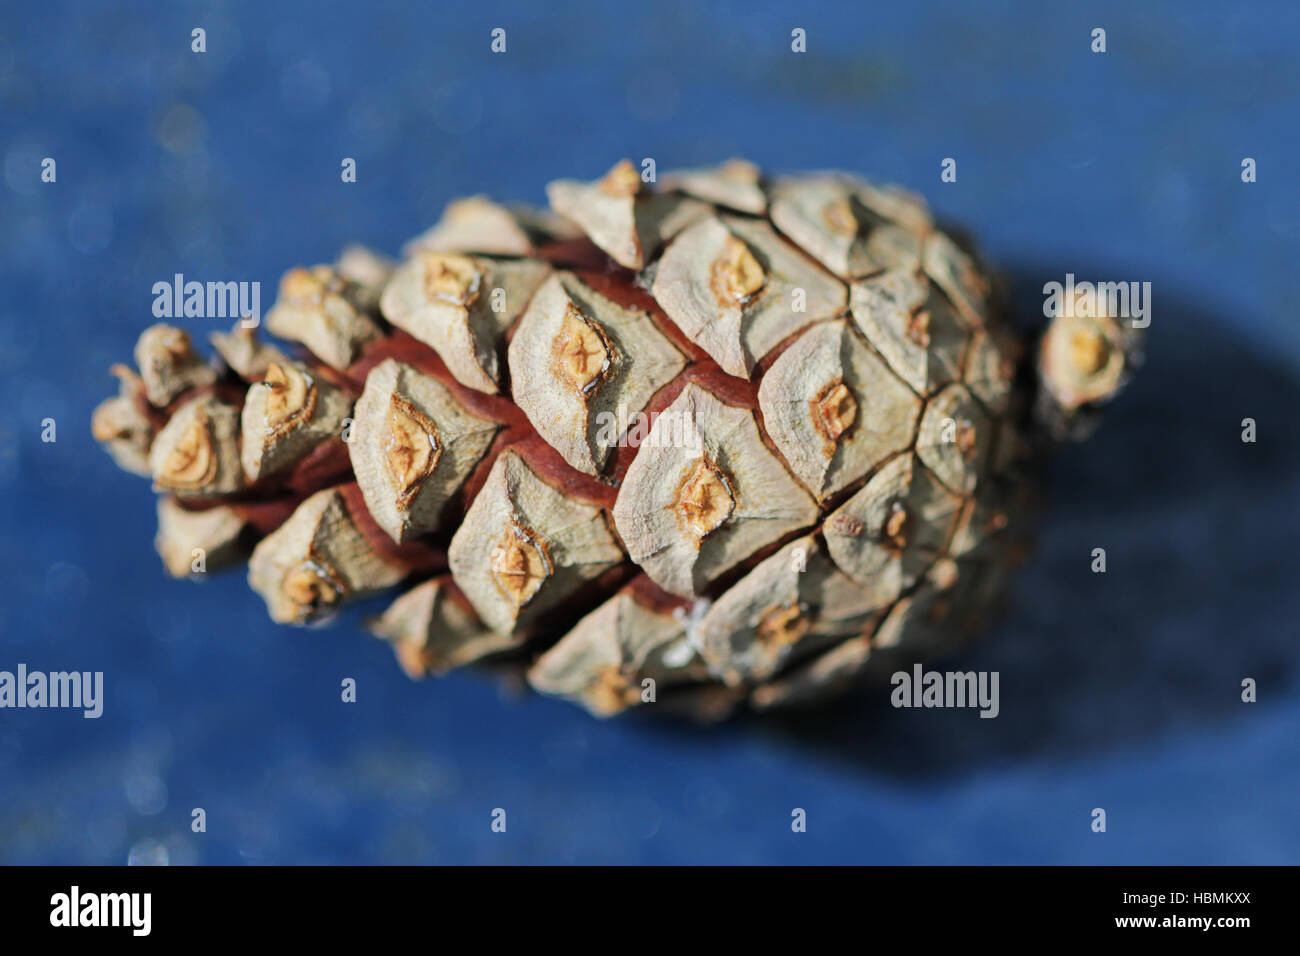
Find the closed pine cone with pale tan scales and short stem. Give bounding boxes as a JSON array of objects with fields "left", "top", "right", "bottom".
[{"left": 94, "top": 160, "right": 1136, "bottom": 717}]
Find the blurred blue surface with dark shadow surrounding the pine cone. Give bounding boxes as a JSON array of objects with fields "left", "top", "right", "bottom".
[{"left": 0, "top": 0, "right": 1300, "bottom": 864}]
